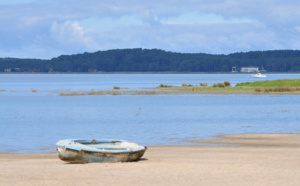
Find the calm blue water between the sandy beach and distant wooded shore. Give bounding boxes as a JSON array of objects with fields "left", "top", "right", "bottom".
[{"left": 0, "top": 74, "right": 300, "bottom": 153}]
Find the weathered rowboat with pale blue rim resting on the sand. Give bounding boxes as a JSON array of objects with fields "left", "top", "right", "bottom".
[{"left": 56, "top": 139, "right": 147, "bottom": 163}]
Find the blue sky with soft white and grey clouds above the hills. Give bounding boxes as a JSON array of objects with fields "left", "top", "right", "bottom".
[{"left": 0, "top": 0, "right": 300, "bottom": 59}]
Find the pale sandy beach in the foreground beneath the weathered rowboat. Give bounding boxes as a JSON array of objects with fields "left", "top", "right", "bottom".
[{"left": 0, "top": 134, "right": 300, "bottom": 186}]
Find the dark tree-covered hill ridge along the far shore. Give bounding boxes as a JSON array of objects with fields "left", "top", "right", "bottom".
[{"left": 0, "top": 48, "right": 300, "bottom": 72}]
